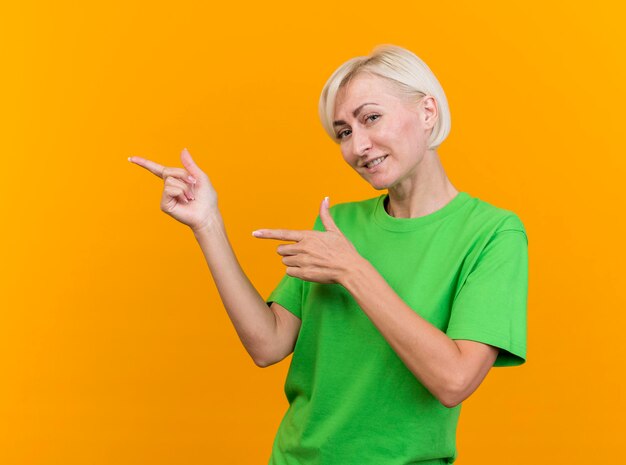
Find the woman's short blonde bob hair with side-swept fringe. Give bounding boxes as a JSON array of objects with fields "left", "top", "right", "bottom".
[{"left": 319, "top": 45, "right": 450, "bottom": 149}]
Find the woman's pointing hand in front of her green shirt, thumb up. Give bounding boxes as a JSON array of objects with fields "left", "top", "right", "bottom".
[{"left": 252, "top": 197, "right": 362, "bottom": 284}]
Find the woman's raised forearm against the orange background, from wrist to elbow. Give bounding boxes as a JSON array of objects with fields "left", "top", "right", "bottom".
[{"left": 192, "top": 213, "right": 278, "bottom": 366}]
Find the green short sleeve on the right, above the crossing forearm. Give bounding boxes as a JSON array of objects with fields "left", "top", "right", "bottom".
[{"left": 446, "top": 229, "right": 528, "bottom": 367}]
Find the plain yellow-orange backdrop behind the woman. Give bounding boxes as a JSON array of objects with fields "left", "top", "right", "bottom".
[{"left": 0, "top": 0, "right": 626, "bottom": 465}]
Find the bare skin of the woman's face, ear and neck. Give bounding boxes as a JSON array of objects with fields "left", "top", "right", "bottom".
[{"left": 333, "top": 74, "right": 458, "bottom": 218}]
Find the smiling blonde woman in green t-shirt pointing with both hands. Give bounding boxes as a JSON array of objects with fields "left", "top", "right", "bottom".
[{"left": 131, "top": 46, "right": 528, "bottom": 465}]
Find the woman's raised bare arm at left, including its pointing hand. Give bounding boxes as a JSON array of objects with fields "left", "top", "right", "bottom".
[{"left": 128, "top": 148, "right": 300, "bottom": 367}]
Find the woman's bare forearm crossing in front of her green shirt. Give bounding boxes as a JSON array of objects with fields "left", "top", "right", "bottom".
[{"left": 341, "top": 259, "right": 464, "bottom": 406}]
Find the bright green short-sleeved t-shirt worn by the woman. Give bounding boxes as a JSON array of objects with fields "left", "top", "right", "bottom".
[{"left": 267, "top": 192, "right": 528, "bottom": 465}]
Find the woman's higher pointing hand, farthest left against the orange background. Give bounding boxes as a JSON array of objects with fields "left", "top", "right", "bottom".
[{"left": 128, "top": 149, "right": 219, "bottom": 232}]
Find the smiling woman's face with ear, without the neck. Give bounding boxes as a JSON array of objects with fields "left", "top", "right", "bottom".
[{"left": 333, "top": 73, "right": 437, "bottom": 190}]
